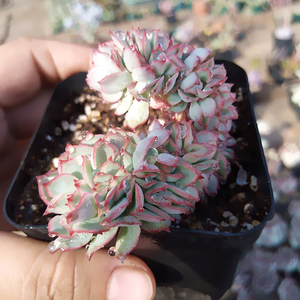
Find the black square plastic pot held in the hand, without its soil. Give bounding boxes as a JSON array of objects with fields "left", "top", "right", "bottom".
[{"left": 4, "top": 61, "right": 274, "bottom": 299}]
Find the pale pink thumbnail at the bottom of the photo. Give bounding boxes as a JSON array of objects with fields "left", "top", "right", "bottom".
[{"left": 107, "top": 267, "right": 153, "bottom": 300}]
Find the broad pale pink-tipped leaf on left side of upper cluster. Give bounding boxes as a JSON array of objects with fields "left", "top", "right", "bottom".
[{"left": 99, "top": 71, "right": 132, "bottom": 94}]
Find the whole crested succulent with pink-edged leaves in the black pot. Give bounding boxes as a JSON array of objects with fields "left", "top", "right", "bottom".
[{"left": 37, "top": 30, "right": 237, "bottom": 261}]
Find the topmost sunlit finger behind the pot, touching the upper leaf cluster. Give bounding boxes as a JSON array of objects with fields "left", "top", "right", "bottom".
[{"left": 0, "top": 39, "right": 92, "bottom": 108}]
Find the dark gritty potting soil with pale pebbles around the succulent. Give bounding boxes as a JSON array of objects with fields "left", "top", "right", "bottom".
[{"left": 10, "top": 89, "right": 270, "bottom": 233}]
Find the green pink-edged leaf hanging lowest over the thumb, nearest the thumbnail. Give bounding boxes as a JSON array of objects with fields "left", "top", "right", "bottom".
[{"left": 115, "top": 225, "right": 141, "bottom": 261}]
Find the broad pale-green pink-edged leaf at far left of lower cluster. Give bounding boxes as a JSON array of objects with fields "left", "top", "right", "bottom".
[{"left": 43, "top": 174, "right": 78, "bottom": 197}]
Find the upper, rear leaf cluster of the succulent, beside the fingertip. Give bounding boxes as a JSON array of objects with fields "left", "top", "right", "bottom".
[{"left": 87, "top": 29, "right": 237, "bottom": 129}]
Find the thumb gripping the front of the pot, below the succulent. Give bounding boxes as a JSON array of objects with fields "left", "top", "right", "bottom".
[{"left": 0, "top": 232, "right": 155, "bottom": 300}]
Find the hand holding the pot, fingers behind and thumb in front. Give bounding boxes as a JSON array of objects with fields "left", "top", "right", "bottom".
[{"left": 0, "top": 39, "right": 155, "bottom": 300}]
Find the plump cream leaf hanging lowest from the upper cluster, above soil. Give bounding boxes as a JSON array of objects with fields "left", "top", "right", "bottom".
[{"left": 125, "top": 99, "right": 149, "bottom": 130}]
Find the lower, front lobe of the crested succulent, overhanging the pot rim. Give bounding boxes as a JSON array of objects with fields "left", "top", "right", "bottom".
[{"left": 37, "top": 120, "right": 224, "bottom": 260}]
